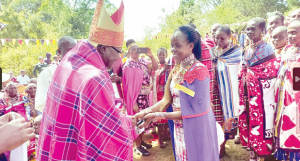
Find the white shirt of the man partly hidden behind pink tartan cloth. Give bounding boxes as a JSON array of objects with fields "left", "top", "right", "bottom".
[{"left": 35, "top": 64, "right": 57, "bottom": 112}]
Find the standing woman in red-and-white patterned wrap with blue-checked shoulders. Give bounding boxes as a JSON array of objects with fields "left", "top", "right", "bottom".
[{"left": 238, "top": 17, "right": 278, "bottom": 161}]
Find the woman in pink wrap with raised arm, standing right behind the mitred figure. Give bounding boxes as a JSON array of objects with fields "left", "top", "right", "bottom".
[{"left": 122, "top": 39, "right": 158, "bottom": 156}]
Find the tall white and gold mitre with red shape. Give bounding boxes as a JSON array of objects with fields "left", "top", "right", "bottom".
[{"left": 88, "top": 0, "right": 124, "bottom": 47}]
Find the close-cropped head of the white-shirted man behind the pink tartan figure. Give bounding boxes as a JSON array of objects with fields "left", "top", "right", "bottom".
[{"left": 57, "top": 36, "right": 76, "bottom": 58}]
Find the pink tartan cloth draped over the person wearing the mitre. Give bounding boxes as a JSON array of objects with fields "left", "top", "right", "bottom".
[{"left": 37, "top": 41, "right": 136, "bottom": 161}]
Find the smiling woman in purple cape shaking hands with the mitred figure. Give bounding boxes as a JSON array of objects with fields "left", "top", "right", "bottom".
[{"left": 135, "top": 26, "right": 219, "bottom": 161}]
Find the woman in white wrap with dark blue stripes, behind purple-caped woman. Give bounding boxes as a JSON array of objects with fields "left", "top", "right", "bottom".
[{"left": 212, "top": 26, "right": 242, "bottom": 156}]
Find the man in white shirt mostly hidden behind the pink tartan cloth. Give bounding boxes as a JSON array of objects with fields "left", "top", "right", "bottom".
[{"left": 35, "top": 36, "right": 76, "bottom": 112}]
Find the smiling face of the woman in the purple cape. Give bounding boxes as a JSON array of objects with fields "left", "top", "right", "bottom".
[{"left": 171, "top": 31, "right": 194, "bottom": 62}]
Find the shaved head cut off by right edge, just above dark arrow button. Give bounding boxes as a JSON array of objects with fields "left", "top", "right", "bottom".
[{"left": 287, "top": 20, "right": 300, "bottom": 47}]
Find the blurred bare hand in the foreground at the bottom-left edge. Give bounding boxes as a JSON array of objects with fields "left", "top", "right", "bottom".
[{"left": 0, "top": 118, "right": 35, "bottom": 154}]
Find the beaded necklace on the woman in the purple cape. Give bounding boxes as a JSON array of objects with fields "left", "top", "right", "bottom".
[{"left": 173, "top": 54, "right": 195, "bottom": 83}]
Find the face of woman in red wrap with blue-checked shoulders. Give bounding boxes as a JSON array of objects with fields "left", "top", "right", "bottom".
[{"left": 246, "top": 21, "right": 263, "bottom": 41}]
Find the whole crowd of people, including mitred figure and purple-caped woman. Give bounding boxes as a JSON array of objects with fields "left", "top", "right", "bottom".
[{"left": 0, "top": 0, "right": 300, "bottom": 161}]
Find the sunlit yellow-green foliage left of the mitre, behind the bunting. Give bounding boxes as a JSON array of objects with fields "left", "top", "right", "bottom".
[{"left": 0, "top": 0, "right": 117, "bottom": 76}]
